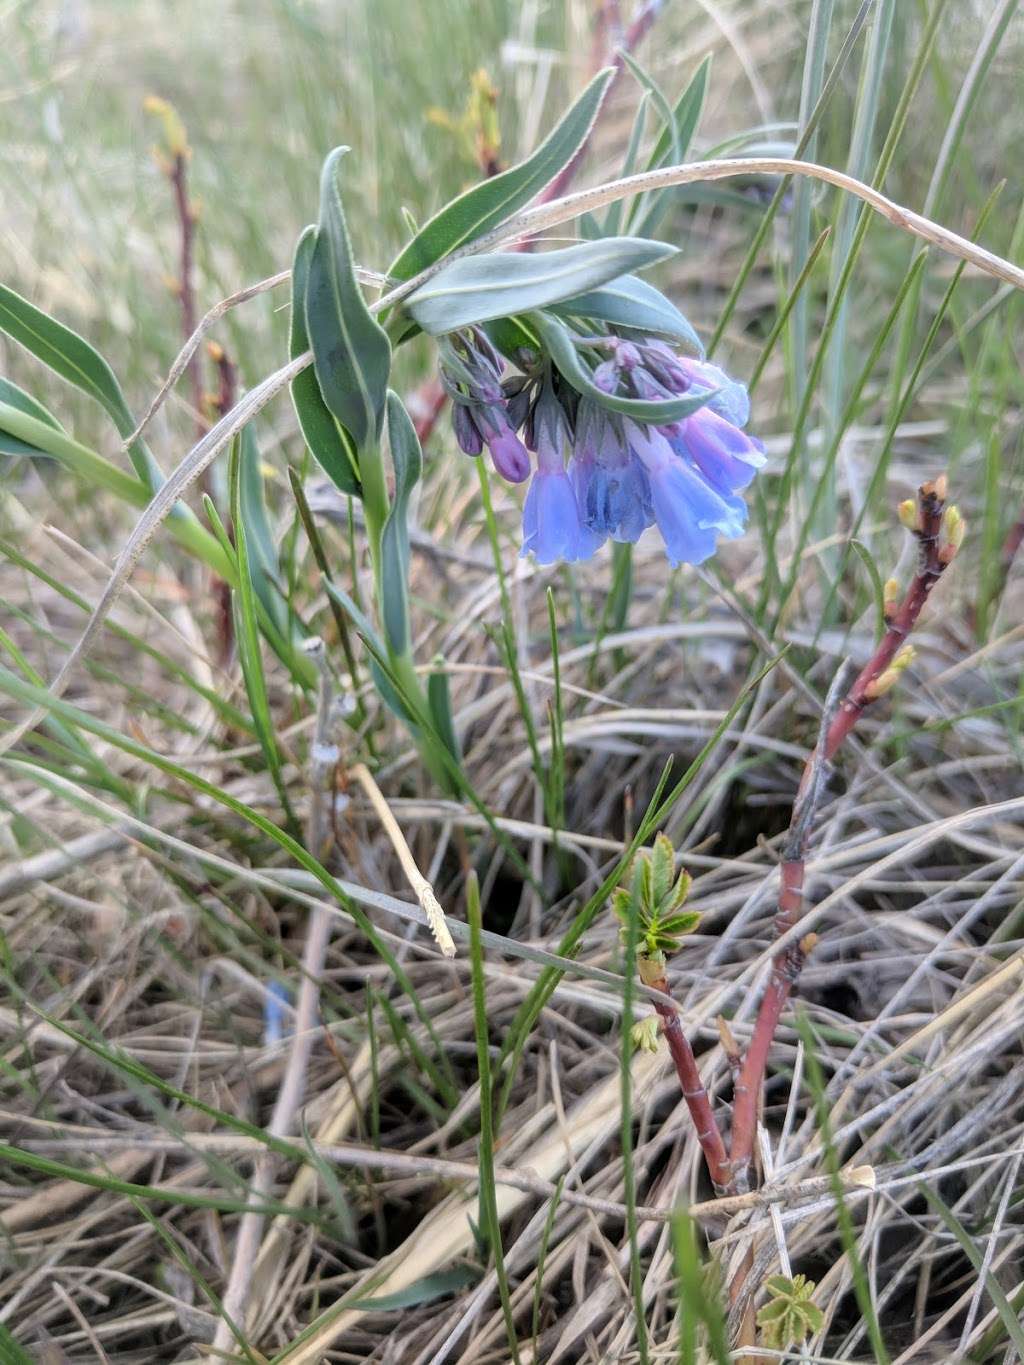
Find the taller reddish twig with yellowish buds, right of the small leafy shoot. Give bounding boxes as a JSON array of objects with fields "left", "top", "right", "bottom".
[{"left": 730, "top": 476, "right": 963, "bottom": 1192}]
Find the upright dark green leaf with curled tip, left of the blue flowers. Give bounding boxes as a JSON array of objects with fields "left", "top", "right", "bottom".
[{"left": 306, "top": 147, "right": 390, "bottom": 450}]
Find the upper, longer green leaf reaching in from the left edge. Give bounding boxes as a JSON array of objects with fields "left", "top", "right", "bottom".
[{"left": 0, "top": 284, "right": 166, "bottom": 491}]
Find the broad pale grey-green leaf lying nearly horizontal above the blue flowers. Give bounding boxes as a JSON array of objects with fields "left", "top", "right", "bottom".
[{"left": 406, "top": 238, "right": 676, "bottom": 336}]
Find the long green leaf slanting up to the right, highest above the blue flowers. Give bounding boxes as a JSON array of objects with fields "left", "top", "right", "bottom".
[{"left": 388, "top": 68, "right": 613, "bottom": 280}]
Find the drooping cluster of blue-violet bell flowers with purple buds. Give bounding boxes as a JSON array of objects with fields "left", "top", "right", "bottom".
[{"left": 441, "top": 329, "right": 765, "bottom": 565}]
